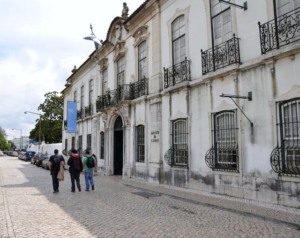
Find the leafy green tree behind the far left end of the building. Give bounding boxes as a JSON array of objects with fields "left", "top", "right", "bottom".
[{"left": 29, "top": 91, "right": 64, "bottom": 143}]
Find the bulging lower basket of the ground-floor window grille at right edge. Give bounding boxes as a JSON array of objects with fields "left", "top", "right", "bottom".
[{"left": 270, "top": 144, "right": 300, "bottom": 176}]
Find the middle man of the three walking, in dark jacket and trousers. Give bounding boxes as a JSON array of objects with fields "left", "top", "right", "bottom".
[{"left": 68, "top": 149, "right": 83, "bottom": 193}]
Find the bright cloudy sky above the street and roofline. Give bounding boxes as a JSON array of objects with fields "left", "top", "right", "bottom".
[{"left": 0, "top": 0, "right": 144, "bottom": 139}]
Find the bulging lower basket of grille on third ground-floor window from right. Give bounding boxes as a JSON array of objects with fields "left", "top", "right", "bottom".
[{"left": 164, "top": 148, "right": 188, "bottom": 168}]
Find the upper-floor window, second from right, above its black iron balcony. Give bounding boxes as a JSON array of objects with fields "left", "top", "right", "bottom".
[{"left": 211, "top": 0, "right": 233, "bottom": 46}]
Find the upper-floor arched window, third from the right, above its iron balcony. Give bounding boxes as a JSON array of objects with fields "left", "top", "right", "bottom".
[{"left": 172, "top": 15, "right": 186, "bottom": 65}]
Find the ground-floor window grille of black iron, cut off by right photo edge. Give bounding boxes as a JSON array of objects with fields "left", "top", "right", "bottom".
[{"left": 270, "top": 98, "right": 300, "bottom": 176}]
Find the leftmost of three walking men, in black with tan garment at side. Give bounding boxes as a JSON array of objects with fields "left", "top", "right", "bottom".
[{"left": 49, "top": 149, "right": 65, "bottom": 193}]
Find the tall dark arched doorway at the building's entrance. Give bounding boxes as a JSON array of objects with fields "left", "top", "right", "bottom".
[{"left": 114, "top": 116, "right": 123, "bottom": 175}]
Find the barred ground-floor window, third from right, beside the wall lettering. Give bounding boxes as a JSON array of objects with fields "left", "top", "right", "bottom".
[{"left": 171, "top": 119, "right": 188, "bottom": 166}]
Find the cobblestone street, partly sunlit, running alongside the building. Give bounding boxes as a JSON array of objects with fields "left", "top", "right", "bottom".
[{"left": 0, "top": 157, "right": 300, "bottom": 238}]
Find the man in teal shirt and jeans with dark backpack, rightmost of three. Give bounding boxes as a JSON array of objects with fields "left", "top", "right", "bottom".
[{"left": 82, "top": 149, "right": 97, "bottom": 191}]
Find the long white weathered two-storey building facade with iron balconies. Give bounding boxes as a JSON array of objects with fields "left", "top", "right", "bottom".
[{"left": 63, "top": 0, "right": 300, "bottom": 206}]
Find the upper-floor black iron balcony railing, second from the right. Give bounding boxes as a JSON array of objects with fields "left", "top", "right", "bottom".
[{"left": 201, "top": 34, "right": 241, "bottom": 75}]
